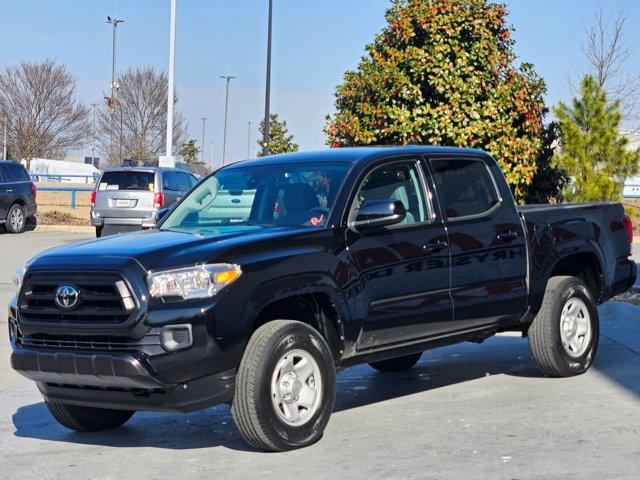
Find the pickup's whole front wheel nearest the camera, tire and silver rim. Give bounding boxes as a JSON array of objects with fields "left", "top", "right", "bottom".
[{"left": 231, "top": 320, "right": 336, "bottom": 451}]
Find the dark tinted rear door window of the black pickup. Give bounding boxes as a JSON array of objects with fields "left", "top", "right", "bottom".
[{"left": 431, "top": 159, "right": 500, "bottom": 219}]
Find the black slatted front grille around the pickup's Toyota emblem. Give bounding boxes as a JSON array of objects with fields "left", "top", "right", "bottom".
[{"left": 18, "top": 272, "right": 135, "bottom": 325}]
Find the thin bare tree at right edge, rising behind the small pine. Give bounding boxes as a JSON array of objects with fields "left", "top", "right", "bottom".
[{"left": 582, "top": 6, "right": 640, "bottom": 130}]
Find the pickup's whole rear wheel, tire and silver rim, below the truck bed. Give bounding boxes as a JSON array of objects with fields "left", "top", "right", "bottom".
[{"left": 528, "top": 276, "right": 600, "bottom": 377}]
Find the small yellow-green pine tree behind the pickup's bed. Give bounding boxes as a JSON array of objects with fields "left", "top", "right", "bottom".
[{"left": 554, "top": 75, "right": 640, "bottom": 202}]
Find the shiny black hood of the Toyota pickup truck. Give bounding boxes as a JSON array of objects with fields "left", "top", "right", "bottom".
[{"left": 29, "top": 226, "right": 316, "bottom": 270}]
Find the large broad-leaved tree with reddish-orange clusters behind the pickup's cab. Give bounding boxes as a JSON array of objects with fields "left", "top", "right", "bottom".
[{"left": 325, "top": 0, "right": 545, "bottom": 201}]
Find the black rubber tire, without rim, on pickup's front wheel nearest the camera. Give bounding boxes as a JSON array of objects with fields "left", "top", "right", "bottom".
[{"left": 231, "top": 320, "right": 336, "bottom": 452}]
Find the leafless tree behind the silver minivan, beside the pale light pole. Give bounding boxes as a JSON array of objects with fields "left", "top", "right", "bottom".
[{"left": 99, "top": 66, "right": 187, "bottom": 165}]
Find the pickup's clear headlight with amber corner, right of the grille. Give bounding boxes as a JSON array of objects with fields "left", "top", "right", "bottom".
[{"left": 147, "top": 263, "right": 242, "bottom": 300}]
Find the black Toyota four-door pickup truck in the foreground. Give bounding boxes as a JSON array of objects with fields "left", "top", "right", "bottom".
[{"left": 9, "top": 146, "right": 636, "bottom": 451}]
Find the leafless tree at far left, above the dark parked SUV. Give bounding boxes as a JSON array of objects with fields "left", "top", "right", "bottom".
[{"left": 0, "top": 59, "right": 89, "bottom": 166}]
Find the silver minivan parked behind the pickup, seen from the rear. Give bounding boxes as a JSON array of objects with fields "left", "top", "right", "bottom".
[{"left": 91, "top": 167, "right": 198, "bottom": 237}]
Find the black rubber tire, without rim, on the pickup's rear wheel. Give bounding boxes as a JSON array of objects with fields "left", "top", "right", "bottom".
[{"left": 528, "top": 276, "right": 600, "bottom": 377}]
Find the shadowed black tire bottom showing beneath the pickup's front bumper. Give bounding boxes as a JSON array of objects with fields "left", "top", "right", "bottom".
[{"left": 45, "top": 402, "right": 135, "bottom": 432}]
